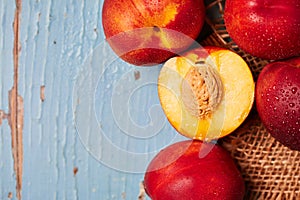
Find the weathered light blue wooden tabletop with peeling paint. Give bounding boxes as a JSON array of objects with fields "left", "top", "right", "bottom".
[{"left": 0, "top": 0, "right": 188, "bottom": 200}]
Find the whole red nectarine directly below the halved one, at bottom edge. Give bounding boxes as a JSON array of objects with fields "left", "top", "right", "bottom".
[{"left": 144, "top": 140, "right": 245, "bottom": 200}]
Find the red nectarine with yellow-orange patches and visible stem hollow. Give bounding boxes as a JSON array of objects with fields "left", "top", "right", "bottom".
[{"left": 102, "top": 0, "right": 205, "bottom": 65}]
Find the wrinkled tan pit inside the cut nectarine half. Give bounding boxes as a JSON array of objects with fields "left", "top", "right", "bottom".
[{"left": 181, "top": 61, "right": 223, "bottom": 119}]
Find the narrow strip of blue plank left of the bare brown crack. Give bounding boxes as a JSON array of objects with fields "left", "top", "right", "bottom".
[{"left": 0, "top": 1, "right": 16, "bottom": 199}]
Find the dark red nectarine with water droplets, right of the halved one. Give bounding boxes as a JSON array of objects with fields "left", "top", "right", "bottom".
[{"left": 256, "top": 57, "right": 300, "bottom": 151}]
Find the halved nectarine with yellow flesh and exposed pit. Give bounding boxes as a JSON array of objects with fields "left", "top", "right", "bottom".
[{"left": 158, "top": 47, "right": 254, "bottom": 141}]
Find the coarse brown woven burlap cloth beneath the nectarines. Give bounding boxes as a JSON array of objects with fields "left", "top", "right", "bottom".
[{"left": 200, "top": 0, "right": 300, "bottom": 200}]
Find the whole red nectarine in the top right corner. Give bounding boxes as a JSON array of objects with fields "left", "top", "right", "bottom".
[{"left": 224, "top": 0, "right": 300, "bottom": 60}]
